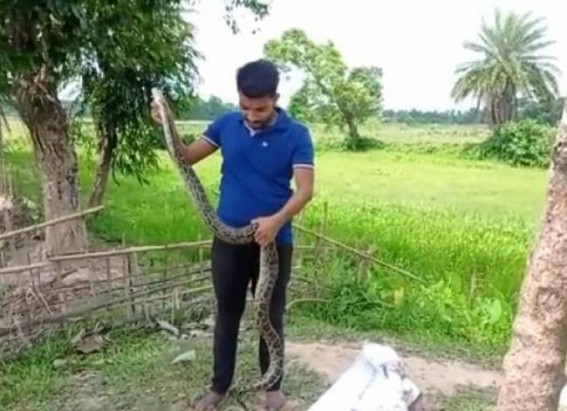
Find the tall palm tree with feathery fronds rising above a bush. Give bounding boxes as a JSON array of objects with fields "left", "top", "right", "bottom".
[{"left": 451, "top": 9, "right": 560, "bottom": 126}]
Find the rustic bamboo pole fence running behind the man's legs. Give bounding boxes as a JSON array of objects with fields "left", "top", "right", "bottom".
[{"left": 0, "top": 196, "right": 418, "bottom": 353}]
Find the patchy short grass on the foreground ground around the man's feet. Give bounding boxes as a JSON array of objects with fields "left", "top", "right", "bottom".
[{"left": 0, "top": 327, "right": 325, "bottom": 411}]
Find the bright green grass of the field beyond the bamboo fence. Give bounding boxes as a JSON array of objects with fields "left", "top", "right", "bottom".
[{"left": 1, "top": 120, "right": 547, "bottom": 350}]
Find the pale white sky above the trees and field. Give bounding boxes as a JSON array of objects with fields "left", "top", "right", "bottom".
[{"left": 188, "top": 0, "right": 567, "bottom": 110}]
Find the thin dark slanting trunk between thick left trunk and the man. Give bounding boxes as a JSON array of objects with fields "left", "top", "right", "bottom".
[{"left": 89, "top": 120, "right": 118, "bottom": 208}]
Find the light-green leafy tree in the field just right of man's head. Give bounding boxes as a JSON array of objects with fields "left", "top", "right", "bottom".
[{"left": 264, "top": 29, "right": 382, "bottom": 148}]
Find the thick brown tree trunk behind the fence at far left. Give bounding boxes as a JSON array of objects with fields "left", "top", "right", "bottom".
[{"left": 13, "top": 72, "right": 87, "bottom": 255}]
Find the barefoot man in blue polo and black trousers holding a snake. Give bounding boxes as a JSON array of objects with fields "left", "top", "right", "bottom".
[{"left": 152, "top": 60, "right": 314, "bottom": 411}]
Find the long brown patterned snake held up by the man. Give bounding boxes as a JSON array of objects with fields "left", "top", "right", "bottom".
[{"left": 152, "top": 88, "right": 284, "bottom": 393}]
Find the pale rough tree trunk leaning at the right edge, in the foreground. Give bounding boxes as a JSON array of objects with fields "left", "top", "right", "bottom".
[{"left": 497, "top": 100, "right": 567, "bottom": 411}]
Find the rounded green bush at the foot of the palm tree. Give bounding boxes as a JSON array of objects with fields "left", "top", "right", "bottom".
[{"left": 478, "top": 119, "right": 555, "bottom": 168}]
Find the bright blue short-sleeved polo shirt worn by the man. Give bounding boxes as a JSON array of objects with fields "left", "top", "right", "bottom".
[{"left": 203, "top": 108, "right": 314, "bottom": 245}]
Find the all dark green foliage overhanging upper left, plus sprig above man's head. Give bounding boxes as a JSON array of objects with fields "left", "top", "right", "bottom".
[{"left": 0, "top": 0, "right": 269, "bottom": 195}]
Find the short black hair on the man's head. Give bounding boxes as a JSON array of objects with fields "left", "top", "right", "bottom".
[{"left": 236, "top": 59, "right": 280, "bottom": 98}]
